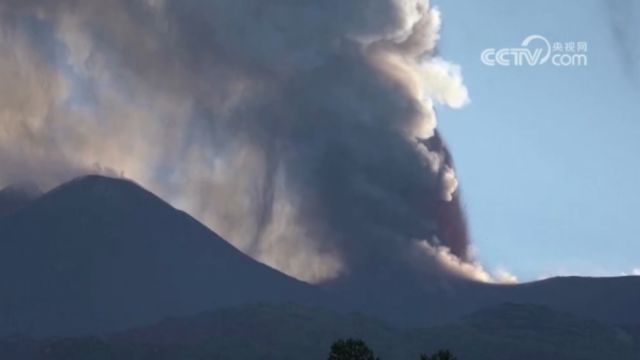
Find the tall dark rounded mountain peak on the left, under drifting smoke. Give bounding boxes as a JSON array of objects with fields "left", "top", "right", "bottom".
[{"left": 0, "top": 176, "right": 326, "bottom": 336}]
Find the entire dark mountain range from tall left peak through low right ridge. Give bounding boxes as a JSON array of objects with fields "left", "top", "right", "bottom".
[{"left": 0, "top": 176, "right": 640, "bottom": 344}]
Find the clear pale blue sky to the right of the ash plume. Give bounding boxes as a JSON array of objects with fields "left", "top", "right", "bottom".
[{"left": 433, "top": 0, "right": 640, "bottom": 280}]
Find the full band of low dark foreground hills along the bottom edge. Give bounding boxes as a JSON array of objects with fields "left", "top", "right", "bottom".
[{"left": 0, "top": 304, "right": 635, "bottom": 360}]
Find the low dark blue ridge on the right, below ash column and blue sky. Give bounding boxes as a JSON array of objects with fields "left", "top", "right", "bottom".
[{"left": 323, "top": 268, "right": 640, "bottom": 327}]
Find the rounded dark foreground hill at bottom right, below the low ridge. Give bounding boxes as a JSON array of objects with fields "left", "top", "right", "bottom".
[{"left": 430, "top": 303, "right": 635, "bottom": 360}]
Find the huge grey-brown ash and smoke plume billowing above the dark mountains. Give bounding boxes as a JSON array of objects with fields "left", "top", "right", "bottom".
[{"left": 0, "top": 0, "right": 498, "bottom": 281}]
